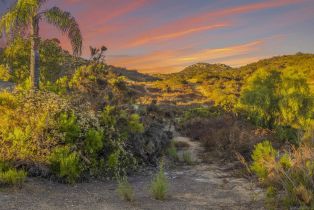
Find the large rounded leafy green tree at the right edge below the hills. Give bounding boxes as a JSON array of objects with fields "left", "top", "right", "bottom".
[{"left": 238, "top": 69, "right": 314, "bottom": 143}]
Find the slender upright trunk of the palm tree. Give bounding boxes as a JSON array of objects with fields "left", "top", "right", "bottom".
[{"left": 30, "top": 17, "right": 40, "bottom": 90}]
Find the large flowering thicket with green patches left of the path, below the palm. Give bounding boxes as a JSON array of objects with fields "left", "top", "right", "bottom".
[{"left": 0, "top": 91, "right": 144, "bottom": 183}]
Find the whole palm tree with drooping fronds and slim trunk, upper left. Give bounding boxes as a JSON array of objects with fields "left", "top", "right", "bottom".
[{"left": 0, "top": 0, "right": 82, "bottom": 89}]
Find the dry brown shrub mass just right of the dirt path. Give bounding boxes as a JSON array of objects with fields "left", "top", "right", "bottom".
[{"left": 182, "top": 114, "right": 271, "bottom": 157}]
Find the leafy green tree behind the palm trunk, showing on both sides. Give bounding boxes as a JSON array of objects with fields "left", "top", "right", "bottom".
[{"left": 0, "top": 36, "right": 86, "bottom": 85}]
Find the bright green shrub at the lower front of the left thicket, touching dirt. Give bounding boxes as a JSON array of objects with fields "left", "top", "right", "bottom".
[{"left": 49, "top": 146, "right": 81, "bottom": 184}]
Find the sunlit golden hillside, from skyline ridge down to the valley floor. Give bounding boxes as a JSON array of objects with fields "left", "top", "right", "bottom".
[{"left": 144, "top": 53, "right": 314, "bottom": 106}]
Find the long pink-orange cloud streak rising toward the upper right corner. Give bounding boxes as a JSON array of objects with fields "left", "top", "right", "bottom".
[{"left": 124, "top": 0, "right": 303, "bottom": 48}]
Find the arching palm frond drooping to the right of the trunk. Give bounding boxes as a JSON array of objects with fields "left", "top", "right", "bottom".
[{"left": 44, "top": 7, "right": 83, "bottom": 55}]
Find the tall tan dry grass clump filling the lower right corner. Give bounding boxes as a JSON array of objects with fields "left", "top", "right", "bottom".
[{"left": 250, "top": 145, "right": 314, "bottom": 209}]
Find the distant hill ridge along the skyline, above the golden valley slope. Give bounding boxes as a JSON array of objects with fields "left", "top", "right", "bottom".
[{"left": 158, "top": 53, "right": 314, "bottom": 85}]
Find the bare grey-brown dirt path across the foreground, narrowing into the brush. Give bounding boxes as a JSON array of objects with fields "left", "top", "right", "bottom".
[{"left": 0, "top": 134, "right": 263, "bottom": 210}]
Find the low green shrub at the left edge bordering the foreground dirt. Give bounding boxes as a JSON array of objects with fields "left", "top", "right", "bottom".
[{"left": 0, "top": 169, "right": 27, "bottom": 186}]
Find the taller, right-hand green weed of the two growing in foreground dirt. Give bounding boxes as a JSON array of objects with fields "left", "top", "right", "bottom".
[{"left": 151, "top": 163, "right": 168, "bottom": 200}]
